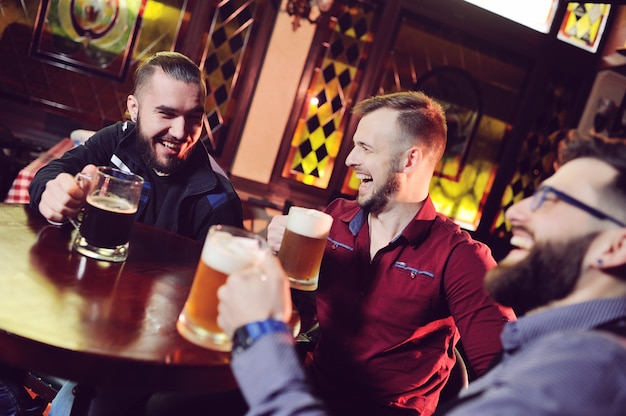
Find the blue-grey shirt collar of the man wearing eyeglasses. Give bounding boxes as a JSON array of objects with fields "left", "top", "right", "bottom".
[{"left": 501, "top": 298, "right": 626, "bottom": 352}]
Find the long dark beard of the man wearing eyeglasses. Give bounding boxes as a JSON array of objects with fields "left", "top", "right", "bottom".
[{"left": 485, "top": 233, "right": 598, "bottom": 315}]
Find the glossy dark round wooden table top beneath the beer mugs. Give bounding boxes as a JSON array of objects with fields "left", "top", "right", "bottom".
[{"left": 0, "top": 204, "right": 236, "bottom": 391}]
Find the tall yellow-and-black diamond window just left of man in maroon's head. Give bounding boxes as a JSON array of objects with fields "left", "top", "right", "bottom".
[{"left": 282, "top": 4, "right": 377, "bottom": 189}]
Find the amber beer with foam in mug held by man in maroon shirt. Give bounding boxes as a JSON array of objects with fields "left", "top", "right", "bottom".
[{"left": 278, "top": 207, "right": 333, "bottom": 291}]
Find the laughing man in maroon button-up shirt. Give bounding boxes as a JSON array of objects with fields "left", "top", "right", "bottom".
[{"left": 268, "top": 92, "right": 515, "bottom": 415}]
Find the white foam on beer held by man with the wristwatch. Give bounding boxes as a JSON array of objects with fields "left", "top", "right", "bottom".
[{"left": 202, "top": 231, "right": 267, "bottom": 274}]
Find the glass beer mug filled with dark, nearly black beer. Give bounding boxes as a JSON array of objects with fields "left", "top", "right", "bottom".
[{"left": 70, "top": 166, "right": 143, "bottom": 262}]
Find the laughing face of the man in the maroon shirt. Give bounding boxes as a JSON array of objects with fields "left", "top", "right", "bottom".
[{"left": 346, "top": 108, "right": 401, "bottom": 213}]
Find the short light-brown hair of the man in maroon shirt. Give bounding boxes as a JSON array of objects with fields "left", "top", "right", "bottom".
[{"left": 352, "top": 91, "right": 448, "bottom": 162}]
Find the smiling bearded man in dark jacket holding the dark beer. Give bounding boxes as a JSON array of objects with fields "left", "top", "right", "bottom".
[{"left": 29, "top": 52, "right": 243, "bottom": 242}]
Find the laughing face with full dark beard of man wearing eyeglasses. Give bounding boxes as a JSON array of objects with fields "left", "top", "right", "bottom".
[{"left": 485, "top": 158, "right": 620, "bottom": 314}]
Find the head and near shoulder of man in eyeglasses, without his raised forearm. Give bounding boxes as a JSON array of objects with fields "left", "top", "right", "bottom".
[{"left": 442, "top": 138, "right": 626, "bottom": 416}]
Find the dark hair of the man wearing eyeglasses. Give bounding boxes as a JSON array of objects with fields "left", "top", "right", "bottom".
[{"left": 563, "top": 136, "right": 626, "bottom": 201}]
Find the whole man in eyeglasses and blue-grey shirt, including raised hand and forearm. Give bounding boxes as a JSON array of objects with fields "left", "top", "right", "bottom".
[{"left": 218, "top": 135, "right": 626, "bottom": 416}]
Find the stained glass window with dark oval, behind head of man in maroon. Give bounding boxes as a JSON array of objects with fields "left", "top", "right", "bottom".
[{"left": 370, "top": 16, "right": 527, "bottom": 230}]
